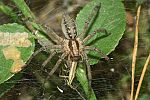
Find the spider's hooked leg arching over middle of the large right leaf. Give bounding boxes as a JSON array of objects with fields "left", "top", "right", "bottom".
[{"left": 83, "top": 28, "right": 110, "bottom": 43}]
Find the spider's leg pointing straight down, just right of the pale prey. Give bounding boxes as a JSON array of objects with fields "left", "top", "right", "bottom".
[{"left": 83, "top": 53, "right": 92, "bottom": 86}]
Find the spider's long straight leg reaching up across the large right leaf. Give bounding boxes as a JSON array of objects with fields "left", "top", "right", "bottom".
[{"left": 79, "top": 3, "right": 101, "bottom": 39}]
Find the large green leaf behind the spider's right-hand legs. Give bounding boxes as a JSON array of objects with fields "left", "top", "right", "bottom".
[{"left": 76, "top": 0, "right": 126, "bottom": 65}]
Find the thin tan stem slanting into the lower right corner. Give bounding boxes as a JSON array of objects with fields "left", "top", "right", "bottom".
[{"left": 134, "top": 54, "right": 150, "bottom": 100}]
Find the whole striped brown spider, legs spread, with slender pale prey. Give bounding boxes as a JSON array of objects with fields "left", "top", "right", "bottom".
[{"left": 24, "top": 4, "right": 109, "bottom": 85}]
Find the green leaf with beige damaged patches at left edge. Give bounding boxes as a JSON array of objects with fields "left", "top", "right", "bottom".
[{"left": 0, "top": 23, "right": 35, "bottom": 84}]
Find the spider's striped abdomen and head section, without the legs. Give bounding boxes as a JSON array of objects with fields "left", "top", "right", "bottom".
[{"left": 61, "top": 15, "right": 83, "bottom": 61}]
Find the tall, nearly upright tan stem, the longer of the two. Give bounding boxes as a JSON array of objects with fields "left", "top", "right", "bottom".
[{"left": 130, "top": 6, "right": 141, "bottom": 100}]
